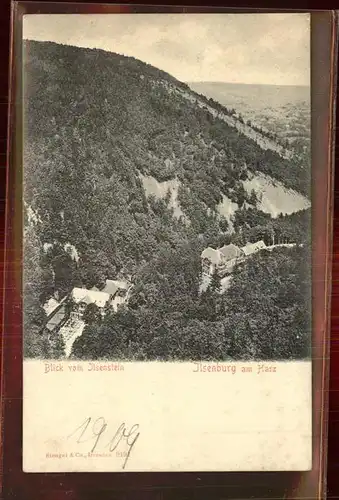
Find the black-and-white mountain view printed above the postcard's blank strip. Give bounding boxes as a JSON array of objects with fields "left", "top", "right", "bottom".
[{"left": 23, "top": 14, "right": 312, "bottom": 366}]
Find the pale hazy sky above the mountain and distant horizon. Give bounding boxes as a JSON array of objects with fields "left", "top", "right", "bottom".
[{"left": 23, "top": 14, "right": 310, "bottom": 85}]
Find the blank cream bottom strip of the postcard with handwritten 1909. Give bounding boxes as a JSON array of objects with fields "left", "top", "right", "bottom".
[{"left": 23, "top": 361, "right": 312, "bottom": 472}]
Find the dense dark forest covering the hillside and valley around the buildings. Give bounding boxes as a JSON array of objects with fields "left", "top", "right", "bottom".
[{"left": 24, "top": 41, "right": 310, "bottom": 359}]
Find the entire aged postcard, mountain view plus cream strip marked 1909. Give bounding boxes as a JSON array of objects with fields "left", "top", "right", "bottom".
[{"left": 23, "top": 14, "right": 312, "bottom": 472}]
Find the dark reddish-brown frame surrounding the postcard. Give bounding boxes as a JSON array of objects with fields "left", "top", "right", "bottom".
[{"left": 2, "top": 3, "right": 336, "bottom": 500}]
